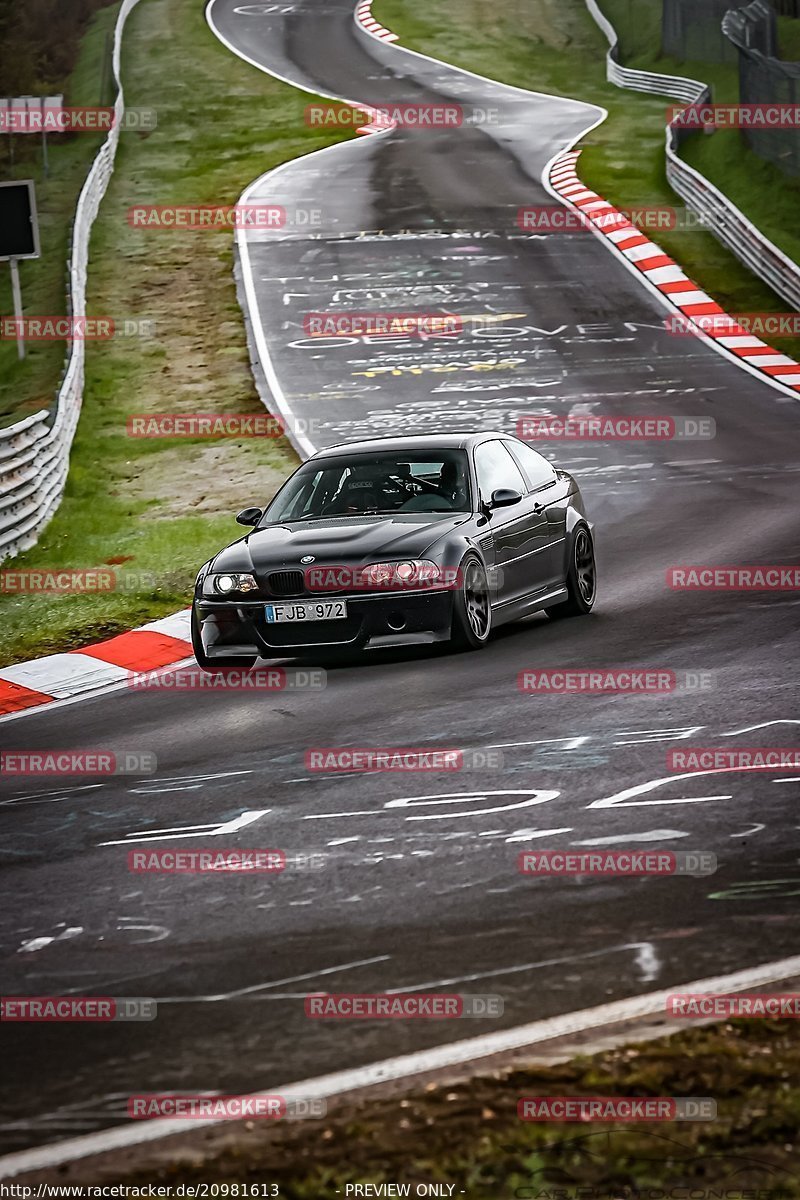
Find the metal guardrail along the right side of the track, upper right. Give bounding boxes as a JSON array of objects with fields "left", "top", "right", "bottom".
[{"left": 587, "top": 0, "right": 800, "bottom": 308}]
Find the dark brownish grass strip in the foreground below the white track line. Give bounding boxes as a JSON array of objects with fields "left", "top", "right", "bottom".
[{"left": 115, "top": 1020, "right": 800, "bottom": 1200}]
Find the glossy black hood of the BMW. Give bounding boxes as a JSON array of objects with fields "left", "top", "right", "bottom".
[{"left": 211, "top": 512, "right": 470, "bottom": 575}]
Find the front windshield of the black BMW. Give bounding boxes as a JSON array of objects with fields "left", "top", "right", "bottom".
[{"left": 263, "top": 450, "right": 471, "bottom": 524}]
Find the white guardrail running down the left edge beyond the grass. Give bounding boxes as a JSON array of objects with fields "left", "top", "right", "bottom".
[{"left": 0, "top": 0, "right": 139, "bottom": 560}]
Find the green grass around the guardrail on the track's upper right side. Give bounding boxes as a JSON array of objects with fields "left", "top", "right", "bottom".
[{"left": 373, "top": 0, "right": 800, "bottom": 358}]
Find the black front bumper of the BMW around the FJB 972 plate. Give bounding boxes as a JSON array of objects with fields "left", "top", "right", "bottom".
[{"left": 194, "top": 590, "right": 453, "bottom": 659}]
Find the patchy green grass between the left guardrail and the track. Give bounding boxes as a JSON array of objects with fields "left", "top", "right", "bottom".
[{"left": 0, "top": 0, "right": 352, "bottom": 664}]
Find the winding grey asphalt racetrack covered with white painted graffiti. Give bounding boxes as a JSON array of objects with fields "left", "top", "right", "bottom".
[{"left": 0, "top": 0, "right": 800, "bottom": 1152}]
